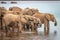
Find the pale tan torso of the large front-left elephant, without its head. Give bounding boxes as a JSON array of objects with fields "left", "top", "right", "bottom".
[{"left": 3, "top": 14, "right": 19, "bottom": 24}]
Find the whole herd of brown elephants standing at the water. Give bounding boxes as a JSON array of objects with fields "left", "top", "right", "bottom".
[{"left": 0, "top": 7, "right": 57, "bottom": 34}]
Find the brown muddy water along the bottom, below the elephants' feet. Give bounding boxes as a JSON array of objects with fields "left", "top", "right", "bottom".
[{"left": 0, "top": 32, "right": 57, "bottom": 40}]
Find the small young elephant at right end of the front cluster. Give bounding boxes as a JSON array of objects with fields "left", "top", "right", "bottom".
[{"left": 30, "top": 17, "right": 42, "bottom": 32}]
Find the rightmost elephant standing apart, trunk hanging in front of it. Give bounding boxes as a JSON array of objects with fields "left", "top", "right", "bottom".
[{"left": 33, "top": 13, "right": 57, "bottom": 34}]
